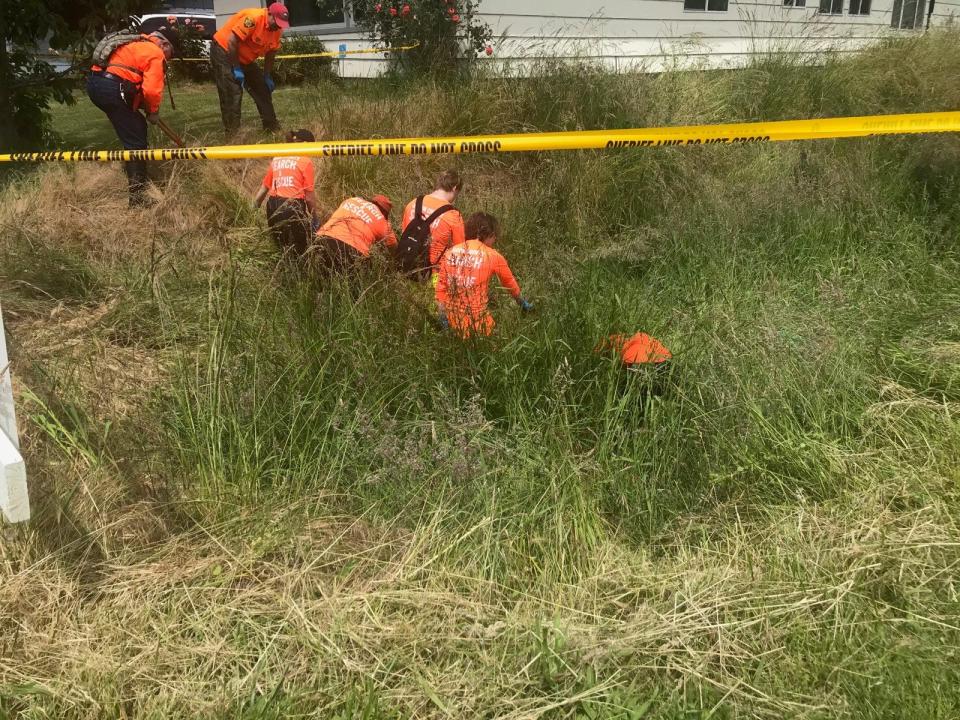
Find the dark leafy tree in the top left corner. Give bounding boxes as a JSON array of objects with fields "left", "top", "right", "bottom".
[{"left": 0, "top": 0, "right": 158, "bottom": 151}]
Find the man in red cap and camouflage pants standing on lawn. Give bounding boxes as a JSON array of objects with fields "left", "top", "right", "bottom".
[{"left": 210, "top": 2, "right": 290, "bottom": 139}]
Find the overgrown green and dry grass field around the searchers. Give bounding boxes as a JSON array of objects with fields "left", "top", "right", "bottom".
[{"left": 0, "top": 33, "right": 960, "bottom": 720}]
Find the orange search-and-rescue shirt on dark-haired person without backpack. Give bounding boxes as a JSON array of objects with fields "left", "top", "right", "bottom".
[{"left": 436, "top": 240, "right": 520, "bottom": 335}]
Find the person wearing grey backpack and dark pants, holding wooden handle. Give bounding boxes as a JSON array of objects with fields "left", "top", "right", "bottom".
[{"left": 87, "top": 29, "right": 176, "bottom": 207}]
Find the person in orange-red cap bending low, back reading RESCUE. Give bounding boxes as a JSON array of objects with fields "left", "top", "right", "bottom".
[{"left": 317, "top": 195, "right": 397, "bottom": 272}]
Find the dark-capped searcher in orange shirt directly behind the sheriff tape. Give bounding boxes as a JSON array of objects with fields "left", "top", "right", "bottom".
[{"left": 253, "top": 130, "right": 317, "bottom": 256}]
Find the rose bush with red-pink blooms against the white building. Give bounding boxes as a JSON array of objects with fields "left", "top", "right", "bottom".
[{"left": 353, "top": 0, "right": 493, "bottom": 75}]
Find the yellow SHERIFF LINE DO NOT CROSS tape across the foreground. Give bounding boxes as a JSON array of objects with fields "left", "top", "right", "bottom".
[{"left": 0, "top": 111, "right": 960, "bottom": 162}]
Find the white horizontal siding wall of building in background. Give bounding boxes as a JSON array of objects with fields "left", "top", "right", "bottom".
[{"left": 216, "top": 0, "right": 960, "bottom": 77}]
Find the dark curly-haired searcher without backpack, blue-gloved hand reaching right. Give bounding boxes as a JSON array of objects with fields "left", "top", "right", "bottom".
[{"left": 436, "top": 213, "right": 533, "bottom": 339}]
